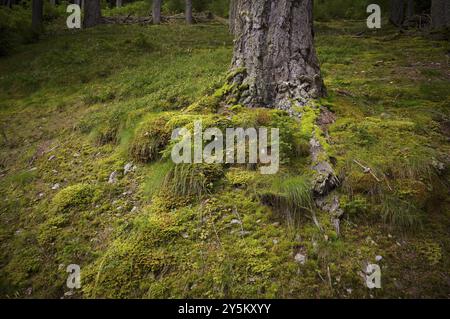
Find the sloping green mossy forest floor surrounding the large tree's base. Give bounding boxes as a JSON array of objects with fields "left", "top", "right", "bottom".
[{"left": 0, "top": 21, "right": 450, "bottom": 298}]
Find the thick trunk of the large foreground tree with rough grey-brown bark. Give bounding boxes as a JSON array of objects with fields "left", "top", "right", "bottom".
[{"left": 232, "top": 0, "right": 326, "bottom": 110}]
